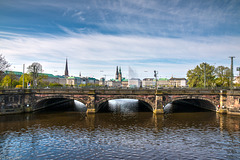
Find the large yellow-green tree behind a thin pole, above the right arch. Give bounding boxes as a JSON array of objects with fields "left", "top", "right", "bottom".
[{"left": 187, "top": 63, "right": 215, "bottom": 88}]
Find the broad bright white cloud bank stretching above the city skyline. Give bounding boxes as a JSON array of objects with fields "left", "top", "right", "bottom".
[{"left": 0, "top": 32, "right": 240, "bottom": 78}]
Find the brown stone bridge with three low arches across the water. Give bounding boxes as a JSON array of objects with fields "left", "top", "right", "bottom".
[{"left": 0, "top": 89, "right": 240, "bottom": 114}]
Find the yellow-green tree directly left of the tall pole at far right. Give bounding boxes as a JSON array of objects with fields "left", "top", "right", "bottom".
[{"left": 215, "top": 66, "right": 231, "bottom": 87}]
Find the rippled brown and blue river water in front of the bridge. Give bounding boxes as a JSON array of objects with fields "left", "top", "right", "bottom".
[{"left": 0, "top": 111, "right": 240, "bottom": 159}]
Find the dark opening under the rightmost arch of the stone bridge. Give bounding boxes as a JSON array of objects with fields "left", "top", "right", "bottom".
[{"left": 163, "top": 99, "right": 216, "bottom": 113}]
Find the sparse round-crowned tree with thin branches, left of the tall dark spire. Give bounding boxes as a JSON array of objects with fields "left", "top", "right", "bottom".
[{"left": 27, "top": 62, "right": 42, "bottom": 87}]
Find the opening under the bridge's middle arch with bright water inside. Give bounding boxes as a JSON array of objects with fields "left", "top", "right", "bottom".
[{"left": 98, "top": 99, "right": 152, "bottom": 114}]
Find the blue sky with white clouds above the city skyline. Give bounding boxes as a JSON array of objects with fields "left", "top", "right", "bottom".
[{"left": 0, "top": 0, "right": 240, "bottom": 79}]
